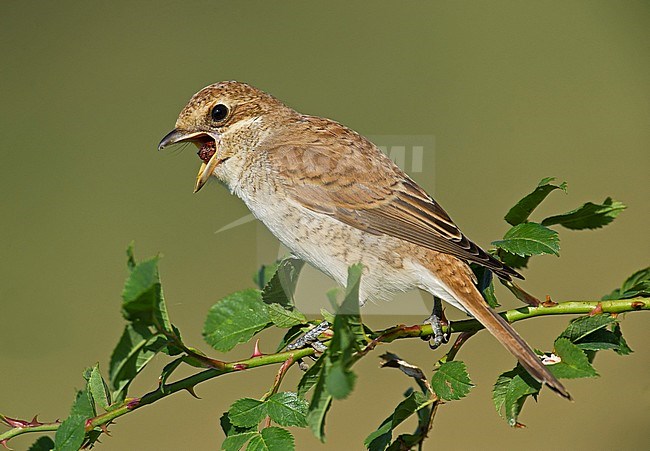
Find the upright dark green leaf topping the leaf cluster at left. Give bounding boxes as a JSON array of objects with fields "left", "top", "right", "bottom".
[{"left": 117, "top": 257, "right": 173, "bottom": 332}]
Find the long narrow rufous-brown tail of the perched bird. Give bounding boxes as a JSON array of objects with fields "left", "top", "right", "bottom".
[{"left": 450, "top": 289, "right": 571, "bottom": 400}]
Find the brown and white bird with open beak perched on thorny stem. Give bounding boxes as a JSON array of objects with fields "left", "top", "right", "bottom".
[{"left": 158, "top": 81, "right": 571, "bottom": 399}]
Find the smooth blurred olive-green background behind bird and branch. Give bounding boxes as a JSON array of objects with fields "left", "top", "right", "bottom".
[{"left": 0, "top": 1, "right": 650, "bottom": 450}]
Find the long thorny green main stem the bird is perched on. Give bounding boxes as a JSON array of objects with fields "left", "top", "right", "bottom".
[{"left": 0, "top": 297, "right": 650, "bottom": 444}]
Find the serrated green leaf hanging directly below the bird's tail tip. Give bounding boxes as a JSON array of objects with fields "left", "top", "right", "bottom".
[{"left": 492, "top": 365, "right": 542, "bottom": 427}]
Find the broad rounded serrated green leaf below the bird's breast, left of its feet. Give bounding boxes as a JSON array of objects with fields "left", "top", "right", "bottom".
[{"left": 203, "top": 289, "right": 270, "bottom": 352}]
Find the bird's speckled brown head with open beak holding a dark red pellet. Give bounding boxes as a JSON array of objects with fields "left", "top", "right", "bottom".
[{"left": 158, "top": 81, "right": 292, "bottom": 192}]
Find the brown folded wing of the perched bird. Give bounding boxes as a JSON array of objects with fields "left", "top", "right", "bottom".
[{"left": 260, "top": 123, "right": 521, "bottom": 280}]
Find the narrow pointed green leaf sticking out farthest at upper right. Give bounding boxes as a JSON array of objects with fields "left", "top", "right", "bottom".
[{"left": 542, "top": 197, "right": 627, "bottom": 230}]
